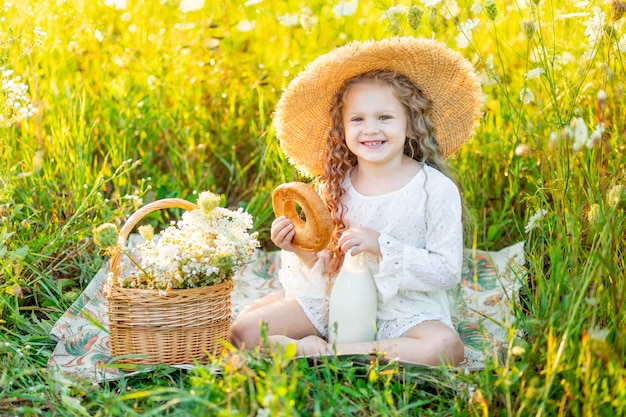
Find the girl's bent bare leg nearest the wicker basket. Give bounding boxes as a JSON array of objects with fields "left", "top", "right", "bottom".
[{"left": 230, "top": 291, "right": 317, "bottom": 348}]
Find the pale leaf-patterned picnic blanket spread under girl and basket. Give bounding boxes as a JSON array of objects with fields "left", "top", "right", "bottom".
[{"left": 48, "top": 234, "right": 526, "bottom": 383}]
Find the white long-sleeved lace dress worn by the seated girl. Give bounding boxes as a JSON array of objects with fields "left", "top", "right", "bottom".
[{"left": 279, "top": 165, "right": 463, "bottom": 340}]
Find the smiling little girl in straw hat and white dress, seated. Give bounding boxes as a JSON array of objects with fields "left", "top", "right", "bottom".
[{"left": 231, "top": 37, "right": 482, "bottom": 365}]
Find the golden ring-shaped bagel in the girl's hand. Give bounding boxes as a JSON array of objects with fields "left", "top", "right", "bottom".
[{"left": 272, "top": 182, "right": 335, "bottom": 252}]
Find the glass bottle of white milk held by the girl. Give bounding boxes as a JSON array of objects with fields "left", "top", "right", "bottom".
[{"left": 328, "top": 251, "right": 378, "bottom": 343}]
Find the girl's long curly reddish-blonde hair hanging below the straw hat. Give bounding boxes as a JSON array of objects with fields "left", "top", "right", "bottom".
[{"left": 318, "top": 70, "right": 468, "bottom": 278}]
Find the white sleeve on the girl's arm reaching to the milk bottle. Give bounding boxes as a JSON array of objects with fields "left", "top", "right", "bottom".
[{"left": 375, "top": 177, "right": 463, "bottom": 299}]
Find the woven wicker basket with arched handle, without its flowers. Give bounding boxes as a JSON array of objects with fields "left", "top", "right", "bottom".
[{"left": 107, "top": 198, "right": 233, "bottom": 365}]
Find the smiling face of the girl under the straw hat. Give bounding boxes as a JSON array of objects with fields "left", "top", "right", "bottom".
[{"left": 342, "top": 81, "right": 407, "bottom": 165}]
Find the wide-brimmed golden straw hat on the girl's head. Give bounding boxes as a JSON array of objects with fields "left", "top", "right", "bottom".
[{"left": 274, "top": 37, "right": 483, "bottom": 176}]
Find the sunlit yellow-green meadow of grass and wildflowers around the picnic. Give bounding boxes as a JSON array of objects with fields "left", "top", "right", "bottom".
[{"left": 0, "top": 0, "right": 626, "bottom": 416}]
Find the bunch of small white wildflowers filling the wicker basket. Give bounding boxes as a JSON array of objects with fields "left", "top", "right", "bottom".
[{"left": 94, "top": 191, "right": 259, "bottom": 295}]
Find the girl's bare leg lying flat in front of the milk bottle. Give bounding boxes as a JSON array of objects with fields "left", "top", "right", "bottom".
[{"left": 270, "top": 321, "right": 464, "bottom": 365}]
